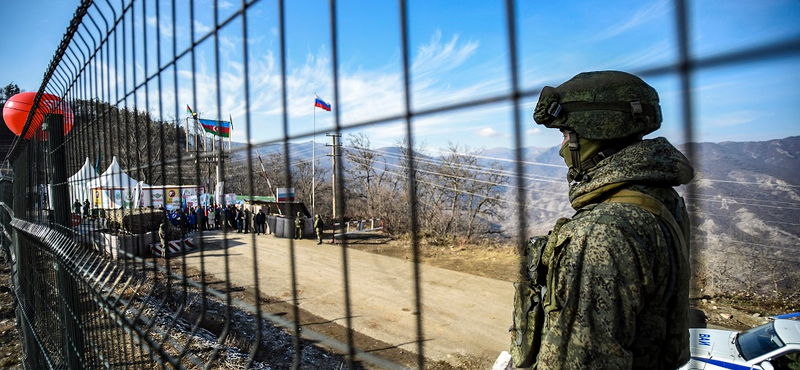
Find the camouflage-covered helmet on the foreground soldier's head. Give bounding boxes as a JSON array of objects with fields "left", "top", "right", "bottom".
[{"left": 533, "top": 71, "right": 661, "bottom": 140}]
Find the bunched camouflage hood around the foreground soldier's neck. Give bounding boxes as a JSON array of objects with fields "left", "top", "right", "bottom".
[{"left": 569, "top": 137, "right": 694, "bottom": 209}]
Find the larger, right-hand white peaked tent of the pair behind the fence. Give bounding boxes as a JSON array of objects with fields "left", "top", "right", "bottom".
[{"left": 87, "top": 157, "right": 150, "bottom": 208}]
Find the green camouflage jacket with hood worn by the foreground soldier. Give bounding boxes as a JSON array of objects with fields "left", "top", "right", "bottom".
[{"left": 537, "top": 138, "right": 693, "bottom": 370}]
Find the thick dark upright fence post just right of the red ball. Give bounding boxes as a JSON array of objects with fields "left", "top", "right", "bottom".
[{"left": 43, "top": 114, "right": 84, "bottom": 369}]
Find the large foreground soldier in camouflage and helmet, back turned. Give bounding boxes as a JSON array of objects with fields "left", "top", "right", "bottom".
[{"left": 520, "top": 71, "right": 694, "bottom": 370}]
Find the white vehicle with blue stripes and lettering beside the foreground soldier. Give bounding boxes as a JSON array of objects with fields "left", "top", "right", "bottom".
[{"left": 680, "top": 319, "right": 800, "bottom": 370}]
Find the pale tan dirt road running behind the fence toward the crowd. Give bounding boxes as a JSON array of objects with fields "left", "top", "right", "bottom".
[{"left": 187, "top": 231, "right": 513, "bottom": 368}]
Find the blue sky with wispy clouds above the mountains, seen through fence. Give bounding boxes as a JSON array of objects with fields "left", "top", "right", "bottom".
[{"left": 0, "top": 0, "right": 800, "bottom": 148}]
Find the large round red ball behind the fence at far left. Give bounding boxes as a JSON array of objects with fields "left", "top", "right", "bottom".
[{"left": 3, "top": 91, "right": 73, "bottom": 140}]
